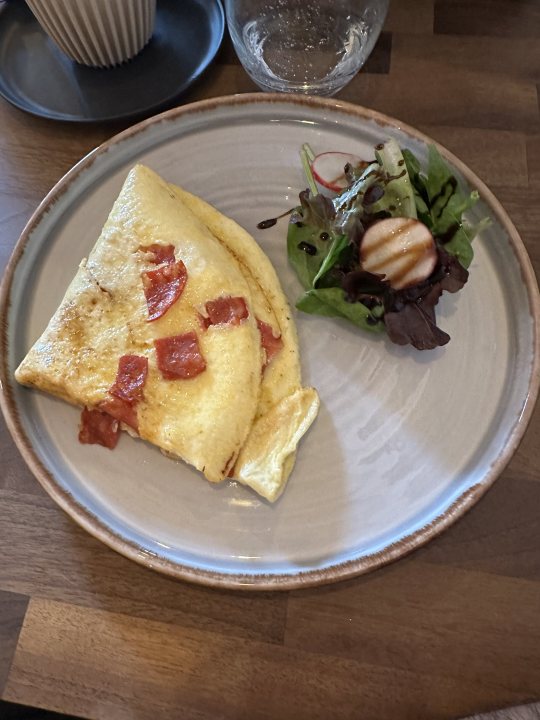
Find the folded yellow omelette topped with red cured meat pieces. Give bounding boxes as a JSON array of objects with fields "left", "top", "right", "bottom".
[{"left": 15, "top": 165, "right": 319, "bottom": 501}]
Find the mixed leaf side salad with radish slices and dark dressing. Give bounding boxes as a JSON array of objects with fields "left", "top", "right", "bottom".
[{"left": 287, "top": 138, "right": 489, "bottom": 350}]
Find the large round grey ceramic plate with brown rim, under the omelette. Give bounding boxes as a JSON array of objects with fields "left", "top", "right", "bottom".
[{"left": 2, "top": 94, "right": 539, "bottom": 589}]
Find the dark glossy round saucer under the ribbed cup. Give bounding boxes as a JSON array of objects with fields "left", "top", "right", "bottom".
[{"left": 0, "top": 0, "right": 225, "bottom": 122}]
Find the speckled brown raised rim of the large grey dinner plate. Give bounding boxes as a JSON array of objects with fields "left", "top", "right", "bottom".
[{"left": 0, "top": 93, "right": 540, "bottom": 591}]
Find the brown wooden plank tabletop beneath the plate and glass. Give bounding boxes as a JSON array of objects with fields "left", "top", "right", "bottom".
[{"left": 0, "top": 0, "right": 540, "bottom": 720}]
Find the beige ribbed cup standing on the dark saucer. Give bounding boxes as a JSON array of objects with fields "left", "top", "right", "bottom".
[{"left": 26, "top": 0, "right": 156, "bottom": 67}]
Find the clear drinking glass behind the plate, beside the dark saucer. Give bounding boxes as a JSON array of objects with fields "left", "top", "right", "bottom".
[{"left": 225, "top": 0, "right": 389, "bottom": 95}]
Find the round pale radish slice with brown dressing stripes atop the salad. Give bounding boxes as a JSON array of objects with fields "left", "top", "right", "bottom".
[{"left": 360, "top": 217, "right": 437, "bottom": 290}]
